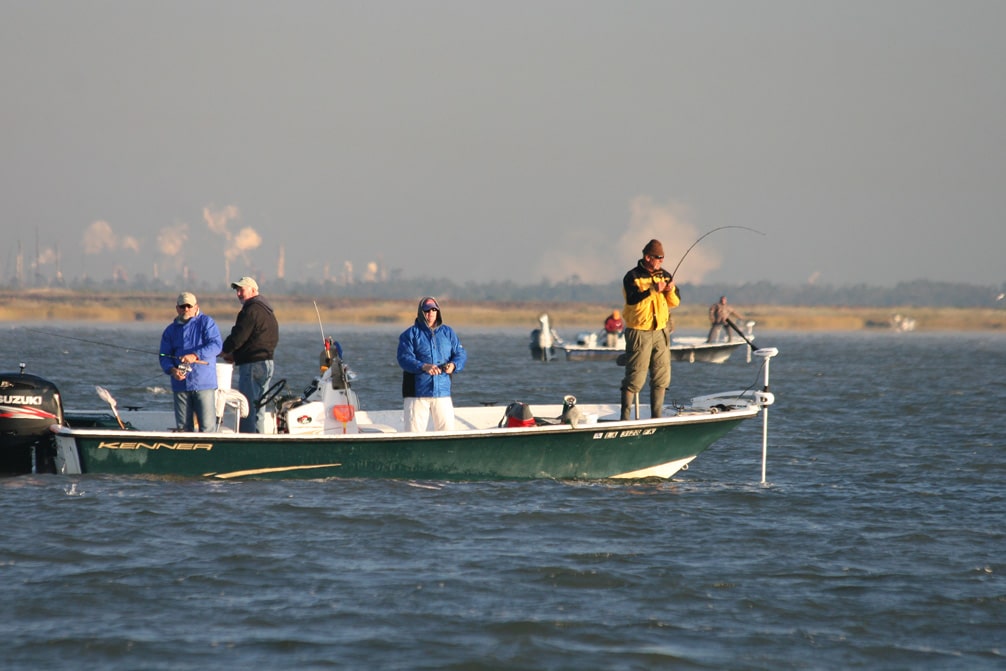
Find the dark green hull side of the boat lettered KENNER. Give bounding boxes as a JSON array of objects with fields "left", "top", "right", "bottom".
[{"left": 55, "top": 410, "right": 756, "bottom": 481}]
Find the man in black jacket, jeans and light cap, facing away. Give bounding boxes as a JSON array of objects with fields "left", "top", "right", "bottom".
[{"left": 222, "top": 278, "right": 280, "bottom": 434}]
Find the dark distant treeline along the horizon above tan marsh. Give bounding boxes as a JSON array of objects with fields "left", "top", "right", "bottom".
[{"left": 7, "top": 278, "right": 1006, "bottom": 308}]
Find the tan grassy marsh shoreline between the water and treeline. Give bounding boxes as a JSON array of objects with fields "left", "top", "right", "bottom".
[{"left": 0, "top": 291, "right": 1006, "bottom": 334}]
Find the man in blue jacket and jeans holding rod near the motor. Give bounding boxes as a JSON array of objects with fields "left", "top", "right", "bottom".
[{"left": 160, "top": 292, "right": 223, "bottom": 432}]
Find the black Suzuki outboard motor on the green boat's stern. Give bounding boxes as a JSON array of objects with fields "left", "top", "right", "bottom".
[{"left": 0, "top": 363, "right": 63, "bottom": 475}]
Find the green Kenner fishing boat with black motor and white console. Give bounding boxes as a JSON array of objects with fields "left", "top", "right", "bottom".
[{"left": 0, "top": 348, "right": 778, "bottom": 481}]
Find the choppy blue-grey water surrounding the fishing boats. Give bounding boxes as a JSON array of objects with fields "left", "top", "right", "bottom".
[{"left": 0, "top": 325, "right": 1006, "bottom": 669}]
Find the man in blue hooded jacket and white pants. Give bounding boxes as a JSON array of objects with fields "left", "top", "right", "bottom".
[{"left": 398, "top": 296, "right": 468, "bottom": 432}]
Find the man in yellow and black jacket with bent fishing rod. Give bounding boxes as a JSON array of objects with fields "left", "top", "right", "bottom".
[{"left": 622, "top": 239, "right": 681, "bottom": 420}]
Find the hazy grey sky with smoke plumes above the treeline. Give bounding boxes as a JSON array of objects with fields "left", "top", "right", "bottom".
[{"left": 0, "top": 0, "right": 1006, "bottom": 293}]
